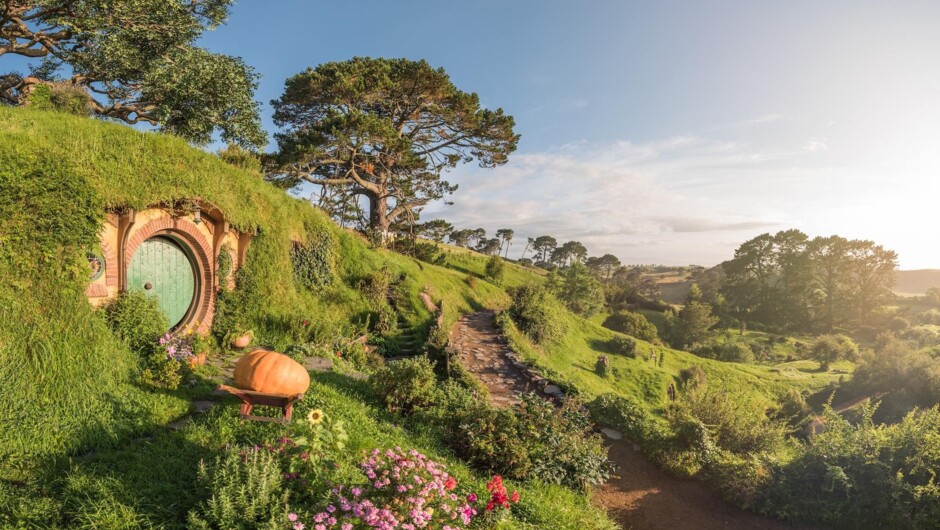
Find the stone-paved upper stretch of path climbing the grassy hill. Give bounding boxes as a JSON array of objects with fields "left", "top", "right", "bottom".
[{"left": 450, "top": 311, "right": 544, "bottom": 407}]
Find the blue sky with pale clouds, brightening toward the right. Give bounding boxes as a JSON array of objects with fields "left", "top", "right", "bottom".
[{"left": 195, "top": 0, "right": 940, "bottom": 269}]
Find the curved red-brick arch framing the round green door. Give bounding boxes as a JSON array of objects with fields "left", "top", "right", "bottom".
[{"left": 122, "top": 216, "right": 215, "bottom": 333}]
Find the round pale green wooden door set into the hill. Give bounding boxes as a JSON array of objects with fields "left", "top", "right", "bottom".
[{"left": 127, "top": 237, "right": 196, "bottom": 327}]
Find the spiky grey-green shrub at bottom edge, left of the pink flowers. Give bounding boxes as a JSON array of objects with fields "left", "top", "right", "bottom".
[{"left": 188, "top": 448, "right": 289, "bottom": 530}]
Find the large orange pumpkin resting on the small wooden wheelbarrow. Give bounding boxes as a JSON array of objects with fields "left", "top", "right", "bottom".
[{"left": 235, "top": 350, "right": 310, "bottom": 396}]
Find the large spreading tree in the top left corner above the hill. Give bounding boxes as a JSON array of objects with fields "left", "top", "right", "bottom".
[{"left": 0, "top": 0, "right": 266, "bottom": 148}]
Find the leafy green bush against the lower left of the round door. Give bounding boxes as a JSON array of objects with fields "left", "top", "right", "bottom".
[{"left": 103, "top": 291, "right": 170, "bottom": 357}]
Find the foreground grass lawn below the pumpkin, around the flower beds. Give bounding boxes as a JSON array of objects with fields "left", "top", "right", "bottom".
[{"left": 9, "top": 373, "right": 612, "bottom": 530}]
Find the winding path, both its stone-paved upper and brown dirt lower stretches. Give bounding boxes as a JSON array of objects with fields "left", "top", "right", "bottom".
[{"left": 451, "top": 311, "right": 804, "bottom": 530}]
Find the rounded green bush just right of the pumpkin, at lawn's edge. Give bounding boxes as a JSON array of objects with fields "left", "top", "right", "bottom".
[{"left": 369, "top": 357, "right": 437, "bottom": 414}]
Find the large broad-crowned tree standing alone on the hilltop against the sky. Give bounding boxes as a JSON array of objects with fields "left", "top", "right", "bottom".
[{"left": 272, "top": 57, "right": 519, "bottom": 239}]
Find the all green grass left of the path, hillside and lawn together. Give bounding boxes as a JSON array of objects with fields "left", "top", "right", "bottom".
[{"left": 0, "top": 108, "right": 612, "bottom": 528}]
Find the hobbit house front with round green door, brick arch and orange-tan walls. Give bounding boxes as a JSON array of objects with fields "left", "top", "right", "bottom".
[{"left": 86, "top": 202, "right": 252, "bottom": 333}]
